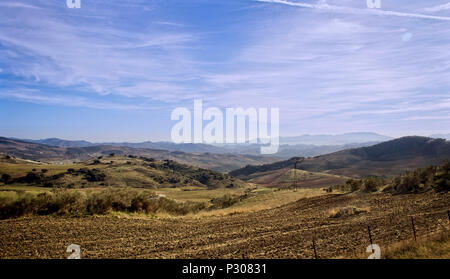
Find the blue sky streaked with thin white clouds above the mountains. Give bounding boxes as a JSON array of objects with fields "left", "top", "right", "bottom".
[{"left": 0, "top": 0, "right": 450, "bottom": 142}]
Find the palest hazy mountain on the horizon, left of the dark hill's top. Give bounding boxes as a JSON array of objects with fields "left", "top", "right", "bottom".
[{"left": 280, "top": 132, "right": 392, "bottom": 145}]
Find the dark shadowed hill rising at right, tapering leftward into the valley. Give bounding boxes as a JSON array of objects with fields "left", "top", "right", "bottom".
[{"left": 230, "top": 136, "right": 450, "bottom": 179}]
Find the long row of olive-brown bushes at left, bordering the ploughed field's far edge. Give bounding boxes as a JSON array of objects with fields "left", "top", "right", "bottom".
[{"left": 0, "top": 188, "right": 206, "bottom": 219}]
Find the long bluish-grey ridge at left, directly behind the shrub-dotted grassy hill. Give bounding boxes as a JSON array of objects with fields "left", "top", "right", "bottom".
[{"left": 0, "top": 137, "right": 277, "bottom": 172}]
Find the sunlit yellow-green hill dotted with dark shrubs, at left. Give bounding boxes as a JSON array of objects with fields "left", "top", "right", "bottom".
[{"left": 0, "top": 155, "right": 245, "bottom": 189}]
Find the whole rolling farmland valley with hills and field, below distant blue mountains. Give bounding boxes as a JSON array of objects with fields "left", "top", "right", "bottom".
[{"left": 0, "top": 137, "right": 450, "bottom": 259}]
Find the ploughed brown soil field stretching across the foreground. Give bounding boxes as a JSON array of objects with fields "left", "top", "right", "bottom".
[{"left": 0, "top": 193, "right": 450, "bottom": 258}]
